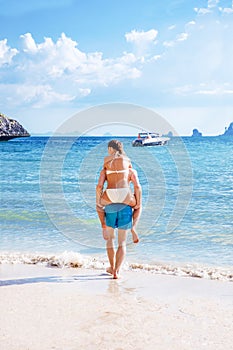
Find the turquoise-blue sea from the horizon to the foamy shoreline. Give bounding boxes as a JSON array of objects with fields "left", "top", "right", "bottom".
[{"left": 0, "top": 136, "right": 233, "bottom": 281}]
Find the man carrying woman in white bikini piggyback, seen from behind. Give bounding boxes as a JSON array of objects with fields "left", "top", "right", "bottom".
[{"left": 96, "top": 140, "right": 141, "bottom": 278}]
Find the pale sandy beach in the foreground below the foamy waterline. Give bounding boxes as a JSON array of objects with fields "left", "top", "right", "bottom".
[{"left": 0, "top": 264, "right": 233, "bottom": 350}]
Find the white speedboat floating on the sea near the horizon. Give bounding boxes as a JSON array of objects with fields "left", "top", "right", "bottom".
[{"left": 132, "top": 131, "right": 170, "bottom": 147}]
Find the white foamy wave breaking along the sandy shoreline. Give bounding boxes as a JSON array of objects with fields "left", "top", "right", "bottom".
[{"left": 0, "top": 252, "right": 233, "bottom": 282}]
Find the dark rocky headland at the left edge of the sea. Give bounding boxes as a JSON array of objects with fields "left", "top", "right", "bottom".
[{"left": 0, "top": 113, "right": 30, "bottom": 141}]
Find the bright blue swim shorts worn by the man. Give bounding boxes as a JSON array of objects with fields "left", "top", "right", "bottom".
[{"left": 105, "top": 203, "right": 133, "bottom": 230}]
